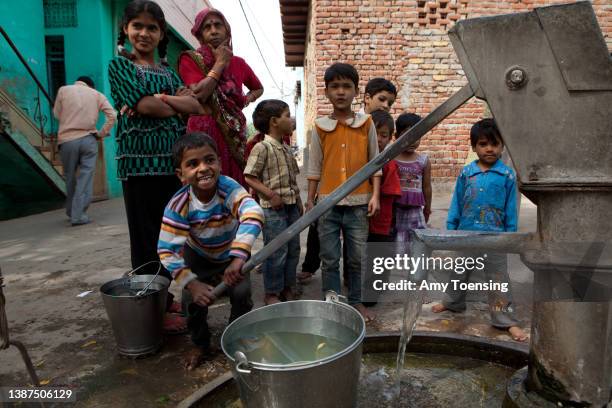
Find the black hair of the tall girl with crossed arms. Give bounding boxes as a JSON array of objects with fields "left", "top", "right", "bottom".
[{"left": 117, "top": 0, "right": 169, "bottom": 65}]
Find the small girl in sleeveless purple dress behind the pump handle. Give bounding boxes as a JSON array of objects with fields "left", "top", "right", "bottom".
[{"left": 394, "top": 113, "right": 431, "bottom": 252}]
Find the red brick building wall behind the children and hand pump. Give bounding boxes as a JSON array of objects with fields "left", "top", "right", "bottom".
[{"left": 304, "top": 0, "right": 612, "bottom": 182}]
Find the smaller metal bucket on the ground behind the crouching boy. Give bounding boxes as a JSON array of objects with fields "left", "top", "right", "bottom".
[{"left": 100, "top": 275, "right": 170, "bottom": 357}]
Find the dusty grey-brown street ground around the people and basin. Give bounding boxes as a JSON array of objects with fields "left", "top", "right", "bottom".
[{"left": 0, "top": 176, "right": 536, "bottom": 407}]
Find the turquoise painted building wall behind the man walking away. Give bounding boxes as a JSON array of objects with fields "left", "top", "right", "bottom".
[{"left": 0, "top": 0, "right": 194, "bottom": 214}]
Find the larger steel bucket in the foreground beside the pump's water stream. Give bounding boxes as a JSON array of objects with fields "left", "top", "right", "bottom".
[{"left": 221, "top": 296, "right": 365, "bottom": 408}]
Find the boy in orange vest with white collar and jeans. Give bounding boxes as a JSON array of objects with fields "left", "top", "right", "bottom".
[{"left": 306, "top": 63, "right": 382, "bottom": 322}]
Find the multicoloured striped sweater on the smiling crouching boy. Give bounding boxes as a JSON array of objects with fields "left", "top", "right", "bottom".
[{"left": 157, "top": 175, "right": 264, "bottom": 287}]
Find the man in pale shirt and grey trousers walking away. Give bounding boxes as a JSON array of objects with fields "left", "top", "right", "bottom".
[{"left": 53, "top": 76, "right": 117, "bottom": 226}]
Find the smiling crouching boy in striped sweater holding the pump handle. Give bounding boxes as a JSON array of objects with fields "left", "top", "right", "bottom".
[{"left": 157, "top": 132, "right": 264, "bottom": 370}]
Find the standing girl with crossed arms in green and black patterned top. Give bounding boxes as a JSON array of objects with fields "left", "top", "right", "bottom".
[{"left": 108, "top": 0, "right": 201, "bottom": 332}]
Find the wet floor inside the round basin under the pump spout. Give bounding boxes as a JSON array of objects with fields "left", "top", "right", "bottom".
[{"left": 204, "top": 353, "right": 515, "bottom": 408}]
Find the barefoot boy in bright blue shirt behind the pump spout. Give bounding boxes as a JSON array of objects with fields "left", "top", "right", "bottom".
[{"left": 432, "top": 119, "right": 527, "bottom": 341}]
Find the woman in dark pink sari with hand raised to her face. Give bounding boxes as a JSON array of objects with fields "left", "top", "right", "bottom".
[{"left": 178, "top": 8, "right": 263, "bottom": 186}]
